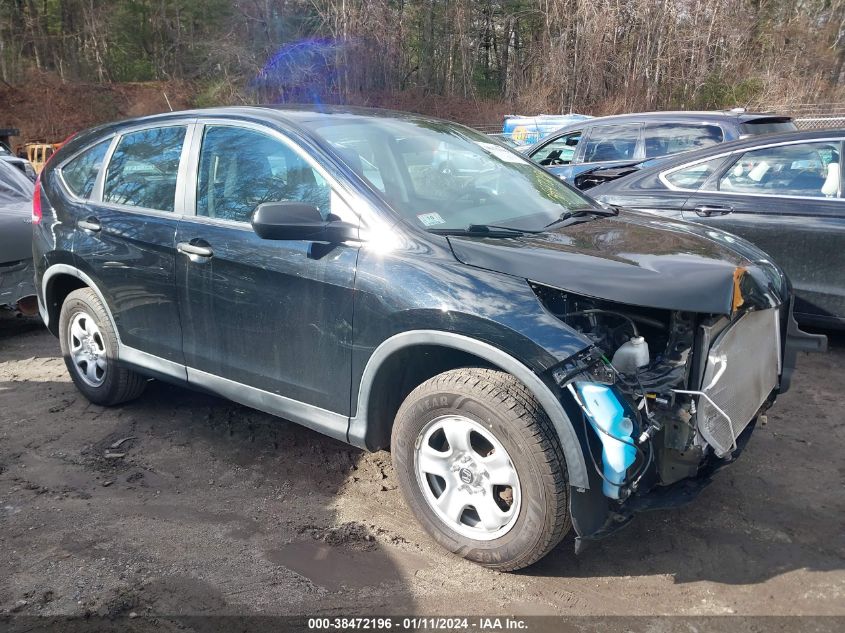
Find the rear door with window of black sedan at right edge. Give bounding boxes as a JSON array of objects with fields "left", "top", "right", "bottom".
[{"left": 670, "top": 138, "right": 845, "bottom": 319}]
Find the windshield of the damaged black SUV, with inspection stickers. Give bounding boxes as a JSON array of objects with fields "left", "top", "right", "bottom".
[{"left": 307, "top": 115, "right": 595, "bottom": 230}]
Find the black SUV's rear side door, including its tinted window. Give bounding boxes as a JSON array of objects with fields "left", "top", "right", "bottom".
[{"left": 69, "top": 121, "right": 193, "bottom": 368}]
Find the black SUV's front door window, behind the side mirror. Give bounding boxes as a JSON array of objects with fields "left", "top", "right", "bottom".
[{"left": 197, "top": 126, "right": 332, "bottom": 222}]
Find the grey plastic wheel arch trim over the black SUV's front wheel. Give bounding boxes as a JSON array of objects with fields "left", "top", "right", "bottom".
[{"left": 347, "top": 330, "right": 590, "bottom": 489}]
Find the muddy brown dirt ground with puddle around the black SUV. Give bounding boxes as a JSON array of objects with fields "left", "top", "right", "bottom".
[{"left": 0, "top": 314, "right": 845, "bottom": 615}]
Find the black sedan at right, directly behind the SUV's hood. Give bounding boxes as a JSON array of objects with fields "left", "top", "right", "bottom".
[{"left": 590, "top": 130, "right": 845, "bottom": 327}]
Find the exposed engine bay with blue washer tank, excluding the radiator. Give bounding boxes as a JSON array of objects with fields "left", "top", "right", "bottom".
[{"left": 532, "top": 284, "right": 772, "bottom": 501}]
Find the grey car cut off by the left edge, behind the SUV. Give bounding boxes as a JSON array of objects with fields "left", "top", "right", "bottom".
[{"left": 0, "top": 160, "right": 37, "bottom": 314}]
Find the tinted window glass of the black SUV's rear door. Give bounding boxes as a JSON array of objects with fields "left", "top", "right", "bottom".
[{"left": 103, "top": 127, "right": 185, "bottom": 211}]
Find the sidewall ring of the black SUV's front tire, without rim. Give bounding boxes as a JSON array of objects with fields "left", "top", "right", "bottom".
[{"left": 391, "top": 390, "right": 551, "bottom": 566}]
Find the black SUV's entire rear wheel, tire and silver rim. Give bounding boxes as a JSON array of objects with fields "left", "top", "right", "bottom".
[{"left": 59, "top": 288, "right": 147, "bottom": 406}]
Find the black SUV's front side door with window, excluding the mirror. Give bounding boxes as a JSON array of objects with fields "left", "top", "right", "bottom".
[{"left": 177, "top": 120, "right": 358, "bottom": 424}]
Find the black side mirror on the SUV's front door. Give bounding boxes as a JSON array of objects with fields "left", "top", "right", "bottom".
[{"left": 252, "top": 202, "right": 358, "bottom": 244}]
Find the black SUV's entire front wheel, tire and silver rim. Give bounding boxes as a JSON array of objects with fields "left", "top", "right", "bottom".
[{"left": 391, "top": 368, "right": 571, "bottom": 571}]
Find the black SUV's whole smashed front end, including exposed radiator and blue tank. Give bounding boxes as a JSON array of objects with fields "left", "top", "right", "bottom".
[{"left": 532, "top": 276, "right": 816, "bottom": 551}]
